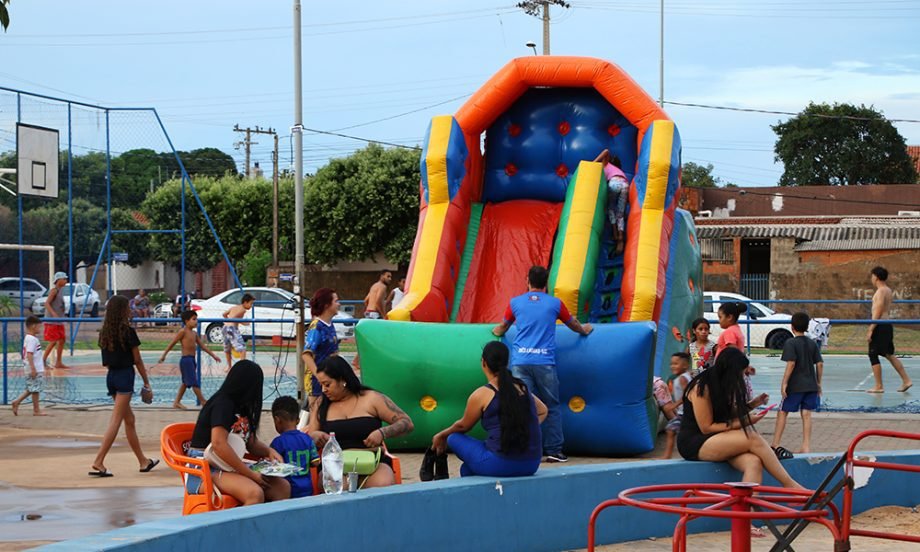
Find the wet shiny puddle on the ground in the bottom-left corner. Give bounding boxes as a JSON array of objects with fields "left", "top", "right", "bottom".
[{"left": 0, "top": 485, "right": 182, "bottom": 542}]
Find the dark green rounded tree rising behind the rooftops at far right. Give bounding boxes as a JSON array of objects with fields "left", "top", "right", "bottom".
[{"left": 772, "top": 103, "right": 917, "bottom": 186}]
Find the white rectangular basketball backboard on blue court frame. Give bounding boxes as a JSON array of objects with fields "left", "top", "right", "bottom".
[{"left": 16, "top": 123, "right": 60, "bottom": 198}]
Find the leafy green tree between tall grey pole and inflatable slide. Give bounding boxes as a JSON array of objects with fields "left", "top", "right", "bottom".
[{"left": 304, "top": 144, "right": 420, "bottom": 264}]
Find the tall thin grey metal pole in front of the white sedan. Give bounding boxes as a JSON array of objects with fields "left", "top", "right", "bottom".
[{"left": 291, "top": 0, "right": 315, "bottom": 406}]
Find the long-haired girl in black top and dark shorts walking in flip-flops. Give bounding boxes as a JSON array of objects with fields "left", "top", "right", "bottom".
[{"left": 89, "top": 295, "right": 160, "bottom": 477}]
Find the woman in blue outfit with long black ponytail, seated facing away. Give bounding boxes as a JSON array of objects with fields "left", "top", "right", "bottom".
[{"left": 431, "top": 341, "right": 547, "bottom": 477}]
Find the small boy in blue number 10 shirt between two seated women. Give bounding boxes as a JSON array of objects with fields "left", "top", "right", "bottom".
[{"left": 272, "top": 397, "right": 319, "bottom": 498}]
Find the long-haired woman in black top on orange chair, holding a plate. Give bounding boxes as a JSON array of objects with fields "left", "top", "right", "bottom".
[{"left": 186, "top": 360, "right": 291, "bottom": 506}]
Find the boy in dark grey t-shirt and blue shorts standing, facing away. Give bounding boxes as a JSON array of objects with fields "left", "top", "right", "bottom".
[{"left": 773, "top": 312, "right": 824, "bottom": 460}]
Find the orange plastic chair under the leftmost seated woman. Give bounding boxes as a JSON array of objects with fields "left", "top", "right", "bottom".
[{"left": 160, "top": 422, "right": 240, "bottom": 516}]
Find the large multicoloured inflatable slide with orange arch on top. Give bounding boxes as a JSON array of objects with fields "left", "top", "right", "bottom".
[{"left": 357, "top": 56, "right": 702, "bottom": 455}]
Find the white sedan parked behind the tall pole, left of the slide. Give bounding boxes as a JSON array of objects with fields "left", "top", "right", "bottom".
[{"left": 192, "top": 287, "right": 355, "bottom": 343}]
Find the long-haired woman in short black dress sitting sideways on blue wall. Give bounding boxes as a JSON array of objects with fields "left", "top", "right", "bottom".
[{"left": 677, "top": 347, "right": 802, "bottom": 489}]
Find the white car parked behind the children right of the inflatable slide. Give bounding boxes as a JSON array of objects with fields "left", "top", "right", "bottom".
[{"left": 703, "top": 291, "right": 792, "bottom": 349}]
